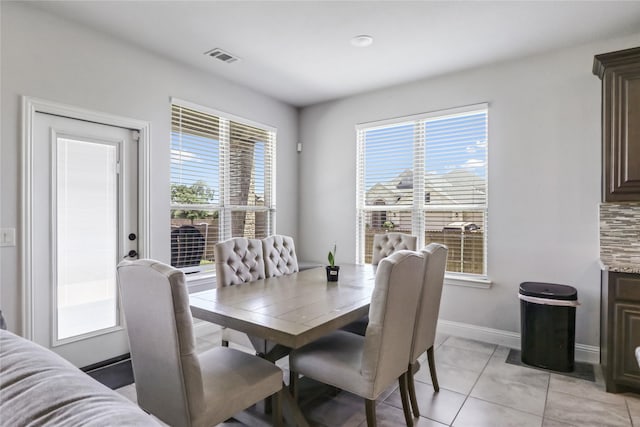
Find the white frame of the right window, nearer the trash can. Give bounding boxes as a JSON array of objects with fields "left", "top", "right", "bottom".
[{"left": 355, "top": 103, "right": 491, "bottom": 288}]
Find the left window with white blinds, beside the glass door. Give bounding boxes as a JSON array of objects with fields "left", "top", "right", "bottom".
[{"left": 171, "top": 99, "right": 276, "bottom": 272}]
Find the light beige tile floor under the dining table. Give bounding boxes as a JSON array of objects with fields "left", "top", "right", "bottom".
[{"left": 118, "top": 322, "right": 640, "bottom": 427}]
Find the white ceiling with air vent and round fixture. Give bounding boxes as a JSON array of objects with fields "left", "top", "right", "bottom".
[{"left": 31, "top": 0, "right": 640, "bottom": 107}]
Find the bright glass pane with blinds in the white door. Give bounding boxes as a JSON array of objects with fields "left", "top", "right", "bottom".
[{"left": 55, "top": 138, "right": 118, "bottom": 340}]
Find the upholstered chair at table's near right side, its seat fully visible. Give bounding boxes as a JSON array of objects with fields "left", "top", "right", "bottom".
[{"left": 289, "top": 251, "right": 424, "bottom": 427}]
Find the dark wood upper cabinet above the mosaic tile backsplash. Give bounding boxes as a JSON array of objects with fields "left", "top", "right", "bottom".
[{"left": 593, "top": 47, "right": 640, "bottom": 202}]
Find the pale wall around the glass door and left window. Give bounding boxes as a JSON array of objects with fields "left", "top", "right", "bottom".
[{"left": 0, "top": 2, "right": 298, "bottom": 331}]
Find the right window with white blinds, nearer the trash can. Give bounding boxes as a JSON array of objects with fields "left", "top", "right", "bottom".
[{"left": 356, "top": 104, "right": 488, "bottom": 276}]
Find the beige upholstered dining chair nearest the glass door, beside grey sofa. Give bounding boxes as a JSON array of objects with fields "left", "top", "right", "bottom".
[{"left": 118, "top": 259, "right": 282, "bottom": 427}]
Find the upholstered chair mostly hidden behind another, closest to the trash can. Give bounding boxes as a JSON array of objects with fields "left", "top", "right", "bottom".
[{"left": 407, "top": 243, "right": 448, "bottom": 417}]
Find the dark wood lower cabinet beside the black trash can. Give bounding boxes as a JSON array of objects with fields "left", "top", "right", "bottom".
[{"left": 600, "top": 271, "right": 640, "bottom": 393}]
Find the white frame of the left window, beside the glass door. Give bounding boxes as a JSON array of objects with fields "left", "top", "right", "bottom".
[{"left": 169, "top": 97, "right": 277, "bottom": 278}]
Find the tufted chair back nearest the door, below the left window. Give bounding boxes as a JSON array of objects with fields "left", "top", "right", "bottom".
[{"left": 214, "top": 237, "right": 265, "bottom": 287}]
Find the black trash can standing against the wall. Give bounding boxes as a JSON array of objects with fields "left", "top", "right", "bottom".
[{"left": 518, "top": 282, "right": 579, "bottom": 372}]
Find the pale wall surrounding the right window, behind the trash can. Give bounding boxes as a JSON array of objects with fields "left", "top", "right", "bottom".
[{"left": 297, "top": 34, "right": 640, "bottom": 346}]
